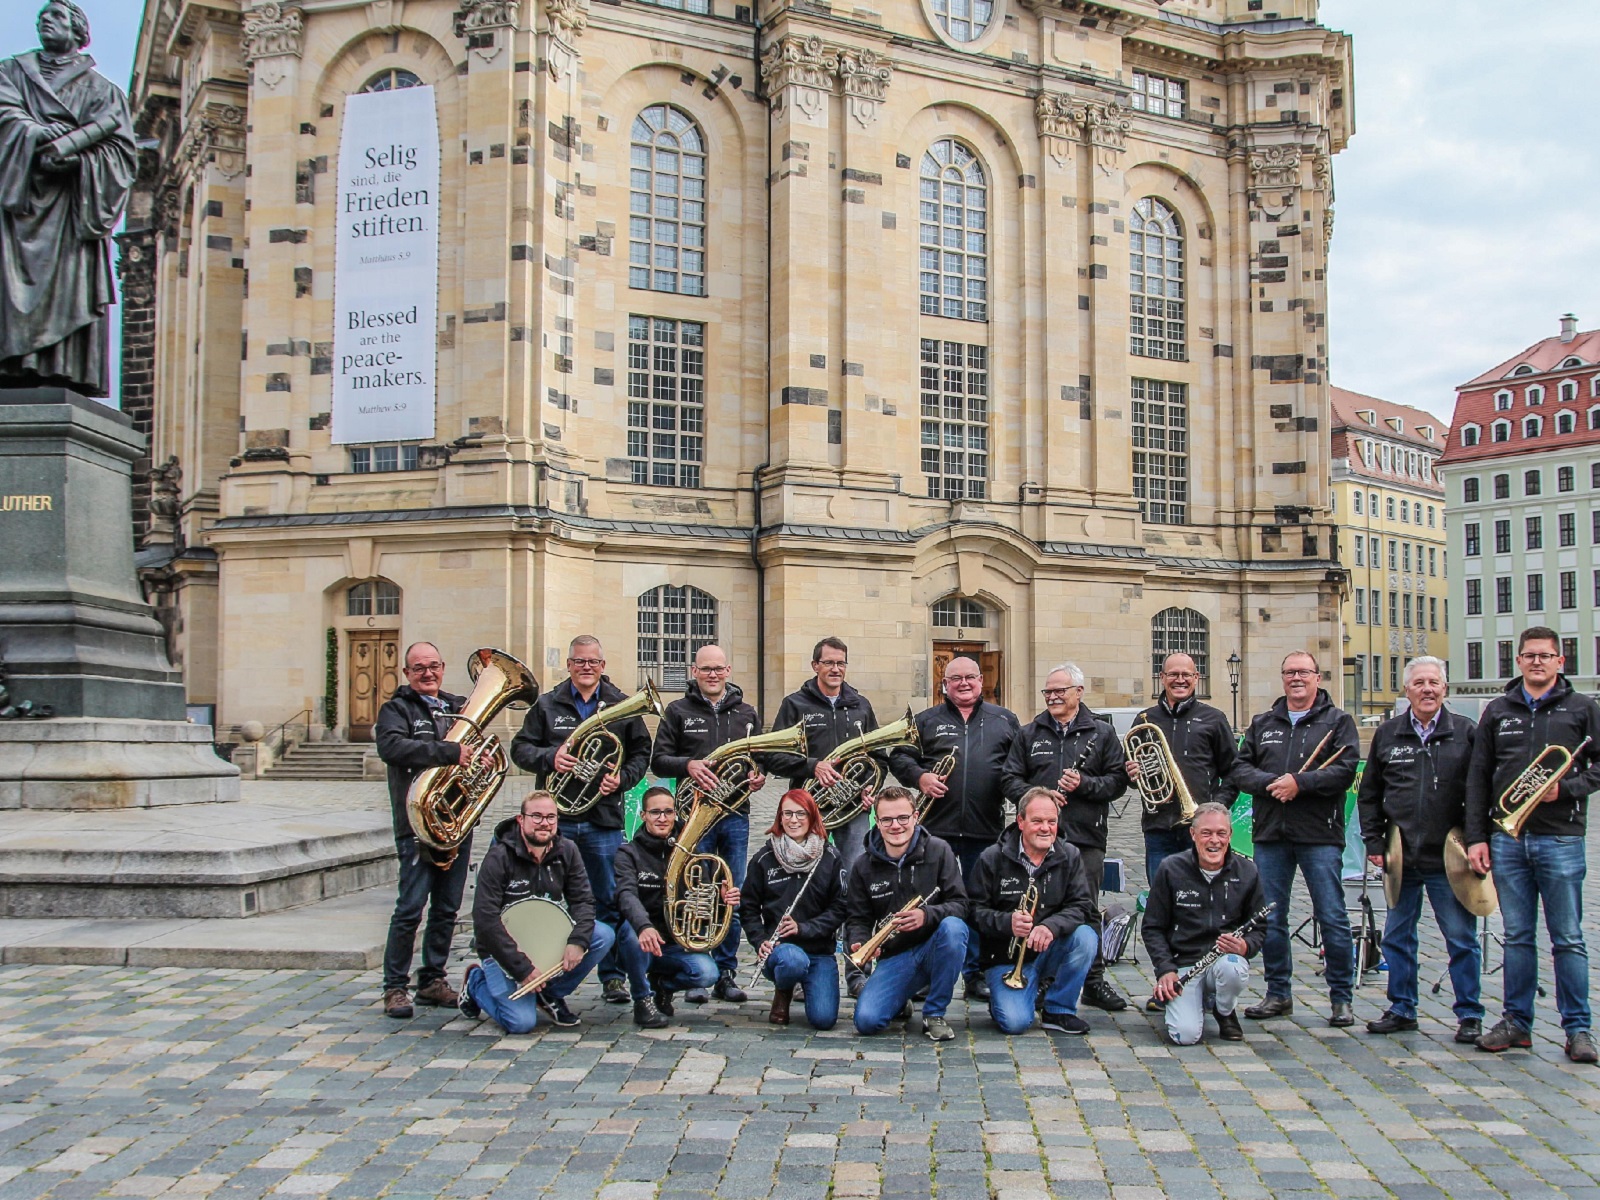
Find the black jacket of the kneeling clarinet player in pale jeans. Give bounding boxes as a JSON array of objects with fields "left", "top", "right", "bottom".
[{"left": 1142, "top": 850, "right": 1267, "bottom": 979}]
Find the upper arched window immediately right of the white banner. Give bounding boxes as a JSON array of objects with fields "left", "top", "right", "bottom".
[{"left": 627, "top": 104, "right": 706, "bottom": 296}]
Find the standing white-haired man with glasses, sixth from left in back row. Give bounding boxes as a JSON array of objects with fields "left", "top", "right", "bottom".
[{"left": 1005, "top": 662, "right": 1128, "bottom": 1013}]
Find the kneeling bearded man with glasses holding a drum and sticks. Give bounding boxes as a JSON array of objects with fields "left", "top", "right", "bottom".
[{"left": 461, "top": 792, "right": 616, "bottom": 1034}]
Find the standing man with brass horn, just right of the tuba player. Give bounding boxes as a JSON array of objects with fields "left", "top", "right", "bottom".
[{"left": 510, "top": 634, "right": 650, "bottom": 1005}]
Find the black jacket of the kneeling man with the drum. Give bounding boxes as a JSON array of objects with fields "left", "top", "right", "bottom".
[{"left": 472, "top": 816, "right": 595, "bottom": 979}]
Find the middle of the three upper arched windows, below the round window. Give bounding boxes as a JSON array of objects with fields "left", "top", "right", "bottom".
[{"left": 918, "top": 138, "right": 989, "bottom": 322}]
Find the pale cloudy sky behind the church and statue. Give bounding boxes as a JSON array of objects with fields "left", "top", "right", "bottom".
[{"left": 0, "top": 0, "right": 1600, "bottom": 418}]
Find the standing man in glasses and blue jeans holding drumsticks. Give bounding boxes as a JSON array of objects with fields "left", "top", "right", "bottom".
[{"left": 1234, "top": 650, "right": 1360, "bottom": 1029}]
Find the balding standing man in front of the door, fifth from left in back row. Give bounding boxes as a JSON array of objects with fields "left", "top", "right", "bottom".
[{"left": 890, "top": 658, "right": 1017, "bottom": 1000}]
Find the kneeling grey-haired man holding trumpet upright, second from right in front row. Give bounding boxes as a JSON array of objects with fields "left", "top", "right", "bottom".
[{"left": 971, "top": 787, "right": 1099, "bottom": 1034}]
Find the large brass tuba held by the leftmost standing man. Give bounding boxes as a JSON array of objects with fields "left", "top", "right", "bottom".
[{"left": 405, "top": 646, "right": 539, "bottom": 869}]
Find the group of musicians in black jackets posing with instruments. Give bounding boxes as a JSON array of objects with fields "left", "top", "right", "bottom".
[{"left": 378, "top": 627, "right": 1600, "bottom": 1062}]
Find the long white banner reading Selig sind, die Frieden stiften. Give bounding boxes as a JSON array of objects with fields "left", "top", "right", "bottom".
[{"left": 333, "top": 86, "right": 438, "bottom": 443}]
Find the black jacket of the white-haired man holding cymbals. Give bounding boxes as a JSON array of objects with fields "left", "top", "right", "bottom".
[{"left": 1357, "top": 709, "right": 1477, "bottom": 870}]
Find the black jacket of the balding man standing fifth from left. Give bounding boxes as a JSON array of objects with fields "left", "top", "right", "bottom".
[{"left": 890, "top": 701, "right": 1021, "bottom": 842}]
